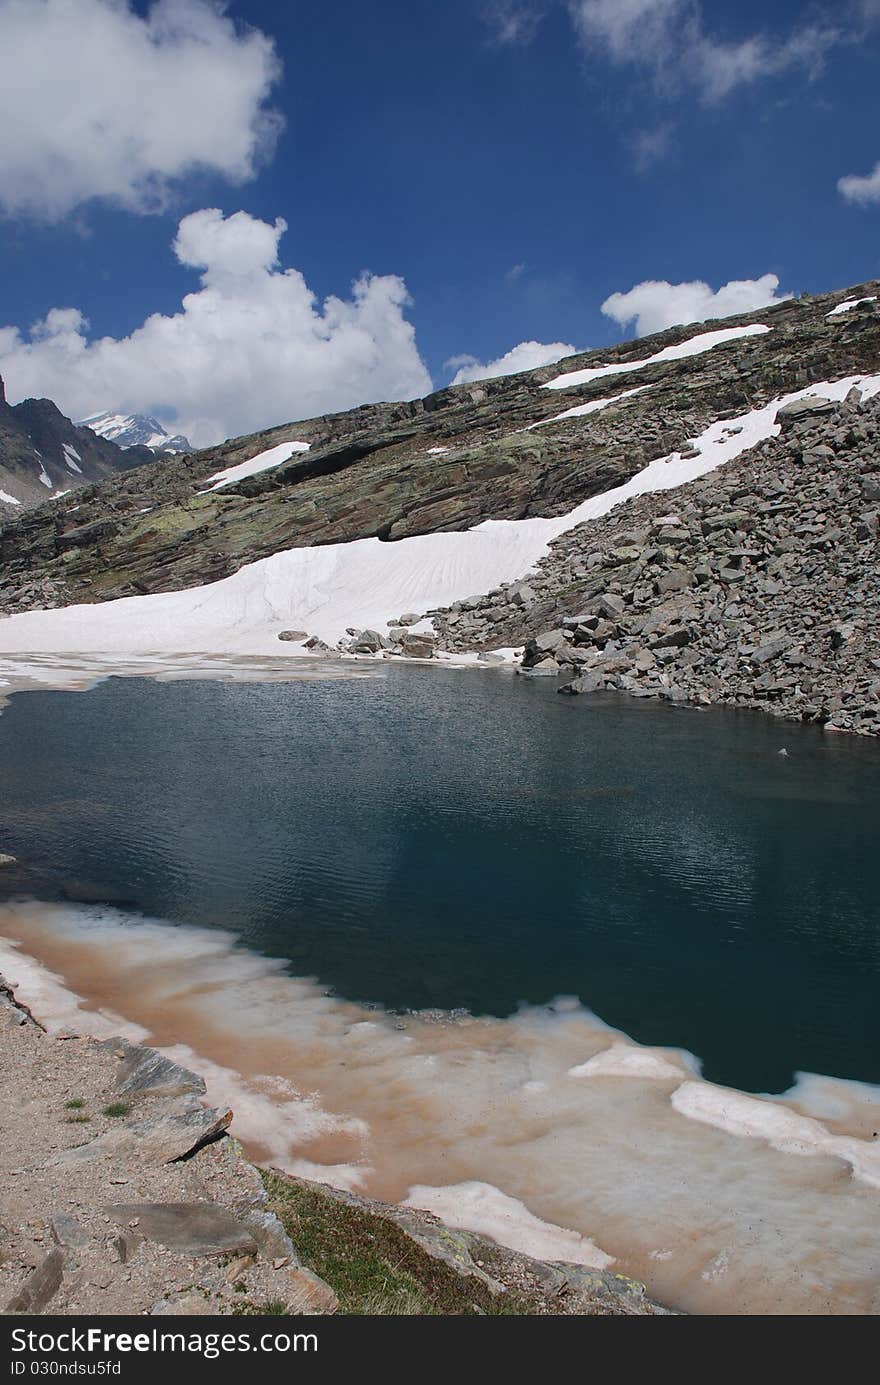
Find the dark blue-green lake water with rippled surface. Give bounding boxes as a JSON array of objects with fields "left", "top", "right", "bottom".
[{"left": 0, "top": 668, "right": 880, "bottom": 1091}]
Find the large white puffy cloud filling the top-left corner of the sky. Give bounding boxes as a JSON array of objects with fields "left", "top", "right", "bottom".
[{"left": 0, "top": 0, "right": 281, "bottom": 220}]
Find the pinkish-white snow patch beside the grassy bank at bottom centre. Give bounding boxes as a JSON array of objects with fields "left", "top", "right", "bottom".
[{"left": 403, "top": 1181, "right": 614, "bottom": 1270}]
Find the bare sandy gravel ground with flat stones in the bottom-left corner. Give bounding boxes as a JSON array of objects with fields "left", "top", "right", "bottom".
[{"left": 0, "top": 992, "right": 334, "bottom": 1314}]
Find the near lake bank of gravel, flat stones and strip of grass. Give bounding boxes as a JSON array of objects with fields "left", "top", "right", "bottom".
[{"left": 0, "top": 958, "right": 668, "bottom": 1316}]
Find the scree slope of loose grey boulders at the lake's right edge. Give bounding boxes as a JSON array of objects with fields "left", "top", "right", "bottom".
[{"left": 434, "top": 388, "right": 880, "bottom": 734}]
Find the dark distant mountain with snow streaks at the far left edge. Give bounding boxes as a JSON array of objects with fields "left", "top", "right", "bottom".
[{"left": 0, "top": 379, "right": 152, "bottom": 522}]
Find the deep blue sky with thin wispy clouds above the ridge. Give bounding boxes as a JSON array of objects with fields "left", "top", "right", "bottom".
[{"left": 0, "top": 0, "right": 880, "bottom": 436}]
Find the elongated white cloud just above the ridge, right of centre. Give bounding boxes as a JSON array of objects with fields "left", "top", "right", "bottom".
[{"left": 601, "top": 274, "right": 791, "bottom": 337}]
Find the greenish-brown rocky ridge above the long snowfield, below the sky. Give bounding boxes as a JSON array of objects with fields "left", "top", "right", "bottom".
[{"left": 0, "top": 284, "right": 880, "bottom": 601}]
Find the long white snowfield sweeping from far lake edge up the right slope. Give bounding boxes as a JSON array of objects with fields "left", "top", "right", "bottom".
[{"left": 0, "top": 375, "right": 880, "bottom": 672}]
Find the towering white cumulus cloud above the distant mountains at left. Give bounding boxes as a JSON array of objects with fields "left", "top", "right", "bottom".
[{"left": 0, "top": 208, "right": 431, "bottom": 446}]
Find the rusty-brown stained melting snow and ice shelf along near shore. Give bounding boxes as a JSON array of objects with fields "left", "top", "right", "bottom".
[{"left": 0, "top": 904, "right": 880, "bottom": 1314}]
